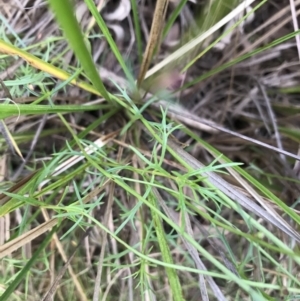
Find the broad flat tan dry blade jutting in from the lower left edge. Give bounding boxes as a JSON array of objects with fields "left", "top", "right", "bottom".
[{"left": 0, "top": 218, "right": 58, "bottom": 259}]
